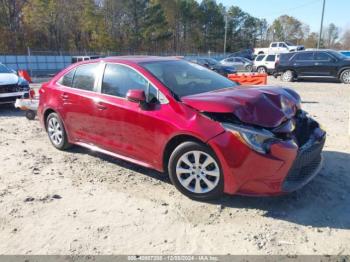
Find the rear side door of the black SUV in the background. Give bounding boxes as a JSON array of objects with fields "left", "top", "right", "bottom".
[{"left": 292, "top": 52, "right": 315, "bottom": 77}]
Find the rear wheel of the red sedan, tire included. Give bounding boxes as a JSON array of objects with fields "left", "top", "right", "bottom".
[{"left": 46, "top": 113, "right": 71, "bottom": 150}]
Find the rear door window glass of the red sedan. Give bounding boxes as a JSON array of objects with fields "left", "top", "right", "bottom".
[{"left": 73, "top": 64, "right": 99, "bottom": 91}]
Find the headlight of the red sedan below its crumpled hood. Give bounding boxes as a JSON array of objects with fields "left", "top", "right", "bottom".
[{"left": 222, "top": 123, "right": 279, "bottom": 154}]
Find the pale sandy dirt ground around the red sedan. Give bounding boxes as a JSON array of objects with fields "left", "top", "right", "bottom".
[{"left": 0, "top": 79, "right": 350, "bottom": 254}]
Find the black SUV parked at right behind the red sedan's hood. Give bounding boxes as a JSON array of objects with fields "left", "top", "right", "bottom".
[{"left": 276, "top": 50, "right": 350, "bottom": 84}]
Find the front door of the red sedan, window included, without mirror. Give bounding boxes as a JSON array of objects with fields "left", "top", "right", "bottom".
[{"left": 91, "top": 63, "right": 170, "bottom": 165}]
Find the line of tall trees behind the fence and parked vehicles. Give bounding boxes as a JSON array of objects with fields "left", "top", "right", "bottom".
[{"left": 0, "top": 0, "right": 350, "bottom": 54}]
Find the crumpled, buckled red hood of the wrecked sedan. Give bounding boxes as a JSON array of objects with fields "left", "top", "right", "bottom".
[{"left": 182, "top": 86, "right": 300, "bottom": 128}]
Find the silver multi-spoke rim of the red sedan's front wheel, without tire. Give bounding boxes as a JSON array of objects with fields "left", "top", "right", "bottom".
[{"left": 176, "top": 151, "right": 220, "bottom": 194}]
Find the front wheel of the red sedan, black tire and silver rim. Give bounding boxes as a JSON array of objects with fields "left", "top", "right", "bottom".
[{"left": 168, "top": 142, "right": 224, "bottom": 201}]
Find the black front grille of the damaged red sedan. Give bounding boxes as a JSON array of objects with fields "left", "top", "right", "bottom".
[{"left": 282, "top": 134, "right": 326, "bottom": 192}]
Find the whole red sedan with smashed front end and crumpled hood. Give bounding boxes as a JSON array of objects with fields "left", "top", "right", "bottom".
[{"left": 38, "top": 57, "right": 326, "bottom": 200}]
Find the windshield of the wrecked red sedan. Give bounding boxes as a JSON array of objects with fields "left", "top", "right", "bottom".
[{"left": 140, "top": 60, "right": 237, "bottom": 98}]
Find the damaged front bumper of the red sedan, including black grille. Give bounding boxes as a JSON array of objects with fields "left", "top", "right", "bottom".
[{"left": 209, "top": 111, "right": 326, "bottom": 196}]
